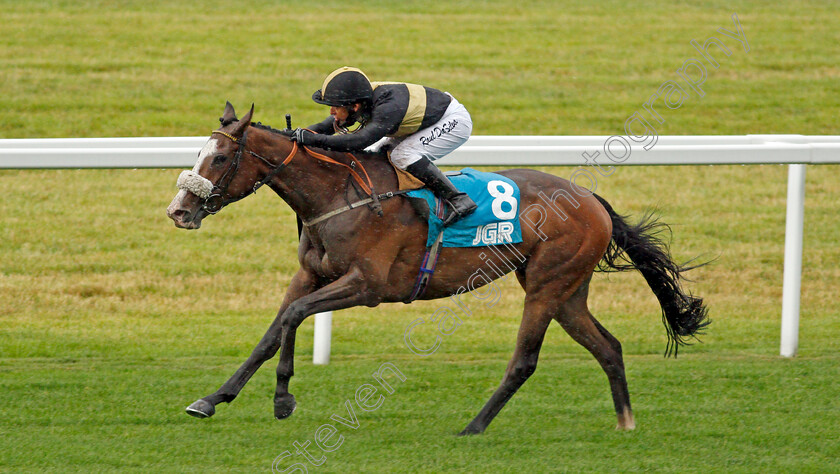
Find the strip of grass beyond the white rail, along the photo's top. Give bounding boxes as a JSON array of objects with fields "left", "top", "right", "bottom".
[{"left": 0, "top": 1, "right": 840, "bottom": 138}]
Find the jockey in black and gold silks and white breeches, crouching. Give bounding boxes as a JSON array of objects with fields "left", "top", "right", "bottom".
[{"left": 291, "top": 67, "right": 476, "bottom": 225}]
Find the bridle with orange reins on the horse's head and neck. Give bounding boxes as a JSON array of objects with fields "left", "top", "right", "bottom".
[{"left": 201, "top": 129, "right": 382, "bottom": 216}]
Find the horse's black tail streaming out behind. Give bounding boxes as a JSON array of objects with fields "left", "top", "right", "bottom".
[{"left": 595, "top": 194, "right": 711, "bottom": 357}]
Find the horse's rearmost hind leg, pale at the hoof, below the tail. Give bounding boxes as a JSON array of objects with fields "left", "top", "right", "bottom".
[{"left": 555, "top": 282, "right": 636, "bottom": 430}]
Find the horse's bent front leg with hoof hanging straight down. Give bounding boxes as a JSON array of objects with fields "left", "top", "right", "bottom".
[{"left": 274, "top": 269, "right": 370, "bottom": 420}]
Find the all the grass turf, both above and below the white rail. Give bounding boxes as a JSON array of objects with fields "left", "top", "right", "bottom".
[{"left": 0, "top": 1, "right": 840, "bottom": 472}]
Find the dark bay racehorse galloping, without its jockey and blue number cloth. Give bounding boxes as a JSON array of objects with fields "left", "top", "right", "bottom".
[{"left": 166, "top": 102, "right": 709, "bottom": 435}]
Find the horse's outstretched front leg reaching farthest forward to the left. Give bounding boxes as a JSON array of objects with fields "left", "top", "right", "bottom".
[{"left": 187, "top": 269, "right": 316, "bottom": 418}]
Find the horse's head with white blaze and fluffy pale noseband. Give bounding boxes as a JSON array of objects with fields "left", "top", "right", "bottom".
[{"left": 166, "top": 102, "right": 257, "bottom": 229}]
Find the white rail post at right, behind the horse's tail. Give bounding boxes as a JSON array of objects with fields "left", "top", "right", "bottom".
[{"left": 781, "top": 164, "right": 805, "bottom": 357}]
